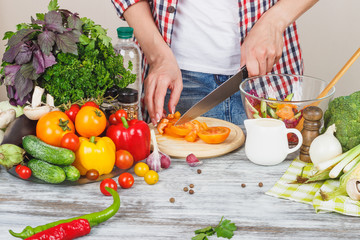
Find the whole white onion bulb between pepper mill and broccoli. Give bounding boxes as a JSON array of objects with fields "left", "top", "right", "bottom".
[{"left": 309, "top": 124, "right": 342, "bottom": 167}]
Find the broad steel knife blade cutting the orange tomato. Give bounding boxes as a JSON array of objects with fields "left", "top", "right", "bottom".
[{"left": 174, "top": 66, "right": 248, "bottom": 125}]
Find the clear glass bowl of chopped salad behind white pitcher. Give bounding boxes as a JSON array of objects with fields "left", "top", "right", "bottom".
[{"left": 240, "top": 74, "right": 335, "bottom": 145}]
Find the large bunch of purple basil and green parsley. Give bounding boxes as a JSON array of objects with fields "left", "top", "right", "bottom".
[{"left": 0, "top": 0, "right": 136, "bottom": 105}]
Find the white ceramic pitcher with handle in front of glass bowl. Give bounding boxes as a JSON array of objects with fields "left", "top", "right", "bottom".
[{"left": 244, "top": 118, "right": 303, "bottom": 165}]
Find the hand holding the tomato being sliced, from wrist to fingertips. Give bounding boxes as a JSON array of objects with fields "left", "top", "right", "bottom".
[{"left": 144, "top": 45, "right": 183, "bottom": 126}]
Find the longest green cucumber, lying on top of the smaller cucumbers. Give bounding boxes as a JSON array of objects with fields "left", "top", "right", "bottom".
[{"left": 22, "top": 135, "right": 75, "bottom": 166}]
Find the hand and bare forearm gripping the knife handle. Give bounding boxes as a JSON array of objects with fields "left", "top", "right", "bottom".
[{"left": 240, "top": 0, "right": 318, "bottom": 76}]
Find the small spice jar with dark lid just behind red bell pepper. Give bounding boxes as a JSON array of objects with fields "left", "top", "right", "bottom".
[{"left": 117, "top": 88, "right": 139, "bottom": 120}]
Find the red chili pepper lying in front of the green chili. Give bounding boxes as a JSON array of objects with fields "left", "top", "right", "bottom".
[{"left": 25, "top": 219, "right": 90, "bottom": 240}]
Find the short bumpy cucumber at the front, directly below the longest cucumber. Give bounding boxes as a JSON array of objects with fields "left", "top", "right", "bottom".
[{"left": 28, "top": 158, "right": 66, "bottom": 183}]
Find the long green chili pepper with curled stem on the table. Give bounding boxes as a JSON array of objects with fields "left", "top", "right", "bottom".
[{"left": 9, "top": 187, "right": 120, "bottom": 239}]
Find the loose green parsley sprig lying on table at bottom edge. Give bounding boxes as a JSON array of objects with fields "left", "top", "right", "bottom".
[{"left": 191, "top": 217, "right": 236, "bottom": 240}]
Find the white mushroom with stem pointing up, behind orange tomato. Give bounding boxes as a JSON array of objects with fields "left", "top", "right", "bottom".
[{"left": 24, "top": 86, "right": 51, "bottom": 120}]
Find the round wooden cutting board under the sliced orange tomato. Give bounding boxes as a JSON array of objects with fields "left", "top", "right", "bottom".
[{"left": 150, "top": 117, "right": 245, "bottom": 158}]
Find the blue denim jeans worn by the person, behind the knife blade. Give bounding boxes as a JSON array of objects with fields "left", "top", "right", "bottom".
[{"left": 164, "top": 70, "right": 247, "bottom": 125}]
